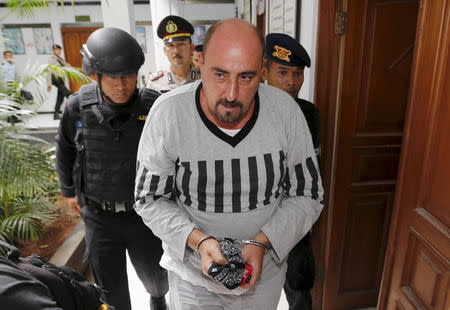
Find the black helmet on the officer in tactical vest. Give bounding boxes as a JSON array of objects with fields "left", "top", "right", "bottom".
[{"left": 81, "top": 27, "right": 144, "bottom": 76}]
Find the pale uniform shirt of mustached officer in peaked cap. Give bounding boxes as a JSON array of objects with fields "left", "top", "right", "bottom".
[{"left": 147, "top": 67, "right": 200, "bottom": 93}]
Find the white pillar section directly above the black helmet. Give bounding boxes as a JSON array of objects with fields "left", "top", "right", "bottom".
[{"left": 101, "top": 0, "right": 136, "bottom": 37}]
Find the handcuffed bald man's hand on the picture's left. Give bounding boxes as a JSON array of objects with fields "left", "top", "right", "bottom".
[{"left": 187, "top": 229, "right": 228, "bottom": 275}]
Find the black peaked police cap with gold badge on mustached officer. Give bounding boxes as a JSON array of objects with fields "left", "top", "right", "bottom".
[{"left": 156, "top": 15, "right": 194, "bottom": 43}]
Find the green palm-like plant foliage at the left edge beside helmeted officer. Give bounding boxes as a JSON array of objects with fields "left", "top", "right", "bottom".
[{"left": 0, "top": 64, "right": 90, "bottom": 254}]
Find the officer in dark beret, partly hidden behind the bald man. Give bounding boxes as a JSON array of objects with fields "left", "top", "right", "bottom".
[{"left": 263, "top": 33, "right": 320, "bottom": 310}]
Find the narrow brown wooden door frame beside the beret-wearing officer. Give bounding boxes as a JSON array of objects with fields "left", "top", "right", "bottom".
[{"left": 312, "top": 0, "right": 345, "bottom": 310}]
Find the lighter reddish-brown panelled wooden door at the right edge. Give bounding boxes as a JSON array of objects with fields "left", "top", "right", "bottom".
[{"left": 379, "top": 0, "right": 450, "bottom": 310}]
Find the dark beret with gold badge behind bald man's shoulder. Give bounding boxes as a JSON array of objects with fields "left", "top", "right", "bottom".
[{"left": 265, "top": 33, "right": 311, "bottom": 68}]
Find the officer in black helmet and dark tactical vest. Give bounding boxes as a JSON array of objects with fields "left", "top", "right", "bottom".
[{"left": 56, "top": 28, "right": 168, "bottom": 310}]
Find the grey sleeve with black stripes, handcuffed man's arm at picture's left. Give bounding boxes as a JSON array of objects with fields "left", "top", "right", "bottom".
[{"left": 135, "top": 109, "right": 194, "bottom": 260}]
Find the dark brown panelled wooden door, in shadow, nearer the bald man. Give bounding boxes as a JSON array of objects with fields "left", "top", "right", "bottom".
[{"left": 319, "top": 0, "right": 419, "bottom": 310}]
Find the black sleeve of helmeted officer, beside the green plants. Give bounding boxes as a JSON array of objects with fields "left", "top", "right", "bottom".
[{"left": 55, "top": 96, "right": 79, "bottom": 197}]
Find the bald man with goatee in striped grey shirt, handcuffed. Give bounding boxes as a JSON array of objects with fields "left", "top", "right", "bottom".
[{"left": 135, "top": 19, "right": 323, "bottom": 310}]
